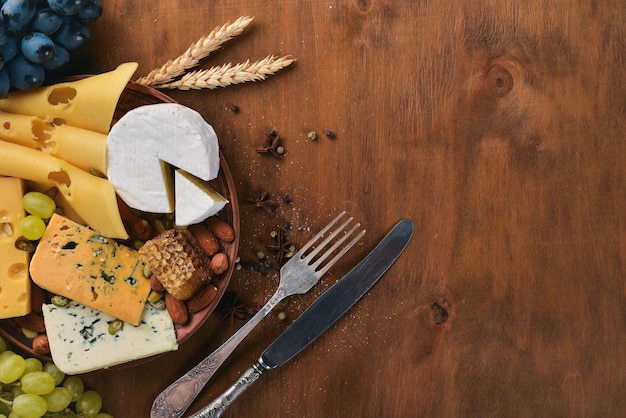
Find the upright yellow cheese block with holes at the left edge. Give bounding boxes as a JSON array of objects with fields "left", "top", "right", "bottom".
[{"left": 0, "top": 177, "right": 30, "bottom": 319}]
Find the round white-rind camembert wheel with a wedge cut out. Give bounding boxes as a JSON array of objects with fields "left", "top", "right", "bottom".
[{"left": 107, "top": 103, "right": 219, "bottom": 213}]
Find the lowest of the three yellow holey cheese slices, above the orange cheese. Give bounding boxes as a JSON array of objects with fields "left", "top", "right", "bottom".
[{"left": 0, "top": 141, "right": 128, "bottom": 239}]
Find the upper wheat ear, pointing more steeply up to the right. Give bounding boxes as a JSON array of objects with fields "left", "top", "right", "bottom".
[{"left": 137, "top": 16, "right": 254, "bottom": 87}]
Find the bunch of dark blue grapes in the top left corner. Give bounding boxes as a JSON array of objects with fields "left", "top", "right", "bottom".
[{"left": 0, "top": 0, "right": 102, "bottom": 98}]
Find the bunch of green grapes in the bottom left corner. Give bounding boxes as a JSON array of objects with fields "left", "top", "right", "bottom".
[{"left": 0, "top": 337, "right": 113, "bottom": 418}]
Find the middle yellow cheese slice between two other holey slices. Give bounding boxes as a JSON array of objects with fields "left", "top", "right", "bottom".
[{"left": 0, "top": 112, "right": 107, "bottom": 174}]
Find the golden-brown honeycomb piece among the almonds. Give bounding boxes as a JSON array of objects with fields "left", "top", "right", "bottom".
[{"left": 139, "top": 228, "right": 211, "bottom": 300}]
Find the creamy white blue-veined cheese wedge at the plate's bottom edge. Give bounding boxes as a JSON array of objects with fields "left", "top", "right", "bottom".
[{"left": 43, "top": 301, "right": 178, "bottom": 375}]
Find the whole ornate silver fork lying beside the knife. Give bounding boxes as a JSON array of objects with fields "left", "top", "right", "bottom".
[{"left": 150, "top": 212, "right": 365, "bottom": 418}]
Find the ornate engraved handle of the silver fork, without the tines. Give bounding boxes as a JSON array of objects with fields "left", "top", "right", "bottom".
[{"left": 150, "top": 288, "right": 286, "bottom": 418}]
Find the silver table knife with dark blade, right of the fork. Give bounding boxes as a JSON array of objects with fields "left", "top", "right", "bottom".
[{"left": 191, "top": 219, "right": 414, "bottom": 418}]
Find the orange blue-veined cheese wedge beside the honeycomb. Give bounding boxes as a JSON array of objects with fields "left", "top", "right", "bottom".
[{"left": 30, "top": 214, "right": 150, "bottom": 325}]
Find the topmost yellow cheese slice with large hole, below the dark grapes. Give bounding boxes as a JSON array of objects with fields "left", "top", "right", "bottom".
[{"left": 0, "top": 62, "right": 137, "bottom": 134}]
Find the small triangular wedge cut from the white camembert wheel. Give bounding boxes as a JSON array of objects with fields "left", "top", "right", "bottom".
[{"left": 174, "top": 170, "right": 228, "bottom": 226}]
